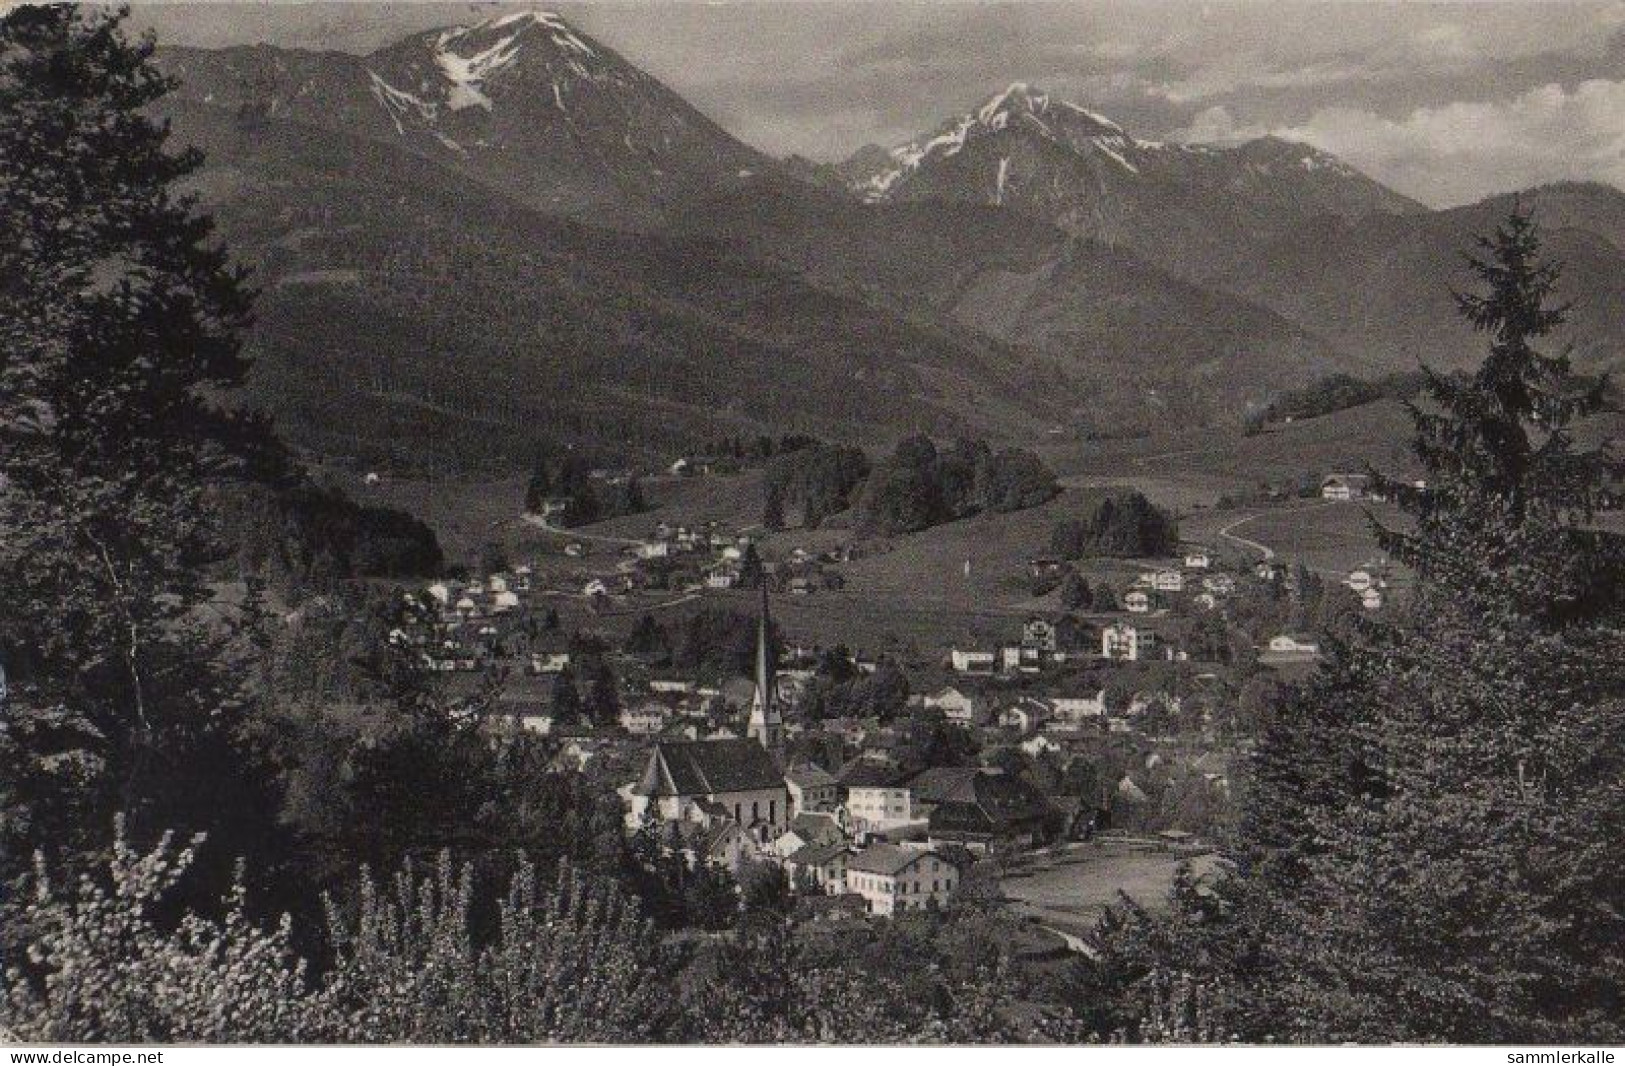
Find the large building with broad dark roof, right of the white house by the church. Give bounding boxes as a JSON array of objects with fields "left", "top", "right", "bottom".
[{"left": 910, "top": 767, "right": 1056, "bottom": 852}]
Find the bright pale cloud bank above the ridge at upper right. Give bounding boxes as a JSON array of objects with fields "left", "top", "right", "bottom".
[{"left": 1170, "top": 78, "right": 1625, "bottom": 206}]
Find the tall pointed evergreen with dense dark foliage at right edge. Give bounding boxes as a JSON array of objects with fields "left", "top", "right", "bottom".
[{"left": 1230, "top": 213, "right": 1625, "bottom": 1042}]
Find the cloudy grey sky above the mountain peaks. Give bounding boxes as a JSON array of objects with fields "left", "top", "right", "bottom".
[{"left": 135, "top": 0, "right": 1625, "bottom": 206}]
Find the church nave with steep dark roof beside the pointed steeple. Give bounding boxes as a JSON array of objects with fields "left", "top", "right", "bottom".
[{"left": 629, "top": 739, "right": 790, "bottom": 842}]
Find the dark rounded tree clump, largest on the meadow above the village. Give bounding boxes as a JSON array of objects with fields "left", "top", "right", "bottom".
[{"left": 855, "top": 436, "right": 1060, "bottom": 536}]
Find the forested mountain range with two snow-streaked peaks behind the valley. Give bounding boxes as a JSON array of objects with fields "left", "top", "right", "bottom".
[{"left": 146, "top": 11, "right": 1625, "bottom": 468}]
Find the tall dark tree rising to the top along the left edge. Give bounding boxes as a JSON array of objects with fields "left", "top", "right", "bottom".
[{"left": 0, "top": 5, "right": 283, "bottom": 877}]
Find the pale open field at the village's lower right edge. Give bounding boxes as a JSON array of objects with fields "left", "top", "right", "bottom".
[{"left": 1001, "top": 840, "right": 1216, "bottom": 934}]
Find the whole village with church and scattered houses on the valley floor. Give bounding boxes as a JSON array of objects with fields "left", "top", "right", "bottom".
[{"left": 380, "top": 448, "right": 1404, "bottom": 951}]
